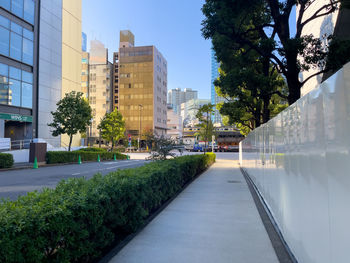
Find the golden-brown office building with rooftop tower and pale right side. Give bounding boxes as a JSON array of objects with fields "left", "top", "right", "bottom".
[{"left": 114, "top": 30, "right": 167, "bottom": 137}]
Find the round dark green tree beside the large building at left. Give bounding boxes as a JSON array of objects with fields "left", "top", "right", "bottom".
[{"left": 48, "top": 91, "right": 92, "bottom": 151}]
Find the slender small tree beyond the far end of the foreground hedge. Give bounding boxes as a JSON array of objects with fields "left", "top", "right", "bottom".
[{"left": 196, "top": 103, "right": 215, "bottom": 153}]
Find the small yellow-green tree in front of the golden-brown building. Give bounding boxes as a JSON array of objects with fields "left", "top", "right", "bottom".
[{"left": 98, "top": 108, "right": 125, "bottom": 151}]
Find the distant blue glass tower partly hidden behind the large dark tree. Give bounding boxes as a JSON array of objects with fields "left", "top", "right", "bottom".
[{"left": 211, "top": 49, "right": 224, "bottom": 125}]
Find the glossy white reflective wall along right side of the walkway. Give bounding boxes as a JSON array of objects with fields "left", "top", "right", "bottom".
[{"left": 242, "top": 63, "right": 350, "bottom": 263}]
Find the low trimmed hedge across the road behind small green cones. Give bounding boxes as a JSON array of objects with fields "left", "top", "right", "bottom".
[{"left": 46, "top": 150, "right": 126, "bottom": 164}]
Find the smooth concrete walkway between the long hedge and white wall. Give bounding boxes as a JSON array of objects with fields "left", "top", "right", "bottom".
[{"left": 110, "top": 155, "right": 278, "bottom": 263}]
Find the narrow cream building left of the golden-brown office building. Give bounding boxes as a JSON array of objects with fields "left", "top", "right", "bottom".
[{"left": 88, "top": 40, "right": 113, "bottom": 138}]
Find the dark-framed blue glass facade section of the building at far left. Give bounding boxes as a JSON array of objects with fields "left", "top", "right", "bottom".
[{"left": 0, "top": 0, "right": 38, "bottom": 140}]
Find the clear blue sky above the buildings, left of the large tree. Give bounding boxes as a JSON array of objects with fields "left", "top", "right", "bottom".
[{"left": 82, "top": 0, "right": 211, "bottom": 99}]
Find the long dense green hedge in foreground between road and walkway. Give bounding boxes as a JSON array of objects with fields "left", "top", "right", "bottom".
[{"left": 0, "top": 154, "right": 215, "bottom": 262}]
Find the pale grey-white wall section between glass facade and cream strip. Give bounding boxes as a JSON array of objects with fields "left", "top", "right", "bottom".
[{"left": 38, "top": 0, "right": 62, "bottom": 146}]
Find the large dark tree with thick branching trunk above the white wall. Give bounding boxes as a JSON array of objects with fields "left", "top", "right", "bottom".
[{"left": 202, "top": 0, "right": 350, "bottom": 104}]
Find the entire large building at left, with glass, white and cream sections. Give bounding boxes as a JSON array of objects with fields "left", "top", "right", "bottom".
[{"left": 0, "top": 0, "right": 81, "bottom": 146}]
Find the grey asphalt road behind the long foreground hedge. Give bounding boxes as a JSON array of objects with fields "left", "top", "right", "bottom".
[{"left": 0, "top": 159, "right": 146, "bottom": 200}]
